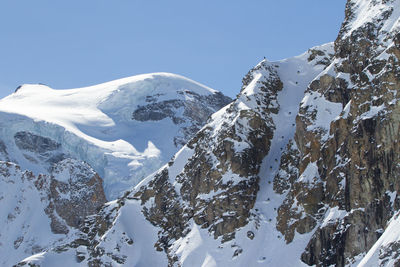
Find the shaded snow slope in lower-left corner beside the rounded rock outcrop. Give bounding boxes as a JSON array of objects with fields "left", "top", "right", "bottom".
[{"left": 0, "top": 162, "right": 65, "bottom": 266}]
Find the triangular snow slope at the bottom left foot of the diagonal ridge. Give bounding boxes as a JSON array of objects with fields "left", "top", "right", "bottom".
[{"left": 23, "top": 200, "right": 168, "bottom": 267}]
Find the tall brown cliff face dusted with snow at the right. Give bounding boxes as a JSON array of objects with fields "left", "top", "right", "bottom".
[{"left": 276, "top": 1, "right": 400, "bottom": 266}]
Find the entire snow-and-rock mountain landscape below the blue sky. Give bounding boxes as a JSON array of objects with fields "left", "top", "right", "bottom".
[{"left": 0, "top": 0, "right": 400, "bottom": 266}]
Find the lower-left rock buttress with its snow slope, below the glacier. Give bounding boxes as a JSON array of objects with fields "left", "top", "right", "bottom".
[{"left": 0, "top": 159, "right": 106, "bottom": 266}]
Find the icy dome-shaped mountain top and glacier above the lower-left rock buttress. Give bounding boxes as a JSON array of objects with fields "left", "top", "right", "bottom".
[{"left": 0, "top": 73, "right": 231, "bottom": 199}]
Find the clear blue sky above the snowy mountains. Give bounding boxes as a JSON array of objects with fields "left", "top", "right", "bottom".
[{"left": 0, "top": 0, "right": 346, "bottom": 97}]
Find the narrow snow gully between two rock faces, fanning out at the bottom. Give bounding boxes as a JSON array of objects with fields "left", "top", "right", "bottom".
[{"left": 175, "top": 43, "right": 333, "bottom": 266}]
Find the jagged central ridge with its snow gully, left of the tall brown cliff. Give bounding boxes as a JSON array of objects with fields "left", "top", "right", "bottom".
[{"left": 16, "top": 38, "right": 334, "bottom": 266}]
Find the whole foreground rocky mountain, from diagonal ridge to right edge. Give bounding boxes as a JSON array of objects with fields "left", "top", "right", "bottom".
[{"left": 4, "top": 0, "right": 400, "bottom": 266}]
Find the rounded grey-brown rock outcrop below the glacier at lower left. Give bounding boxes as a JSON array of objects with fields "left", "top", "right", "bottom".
[{"left": 44, "top": 159, "right": 106, "bottom": 234}]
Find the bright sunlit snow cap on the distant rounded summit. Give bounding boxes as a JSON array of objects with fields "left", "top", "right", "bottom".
[{"left": 0, "top": 73, "right": 217, "bottom": 131}]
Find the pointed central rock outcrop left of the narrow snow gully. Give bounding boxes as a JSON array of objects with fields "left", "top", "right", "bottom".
[{"left": 134, "top": 62, "right": 282, "bottom": 261}]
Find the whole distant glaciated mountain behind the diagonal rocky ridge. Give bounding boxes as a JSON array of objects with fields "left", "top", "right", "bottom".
[{"left": 0, "top": 73, "right": 232, "bottom": 266}]
